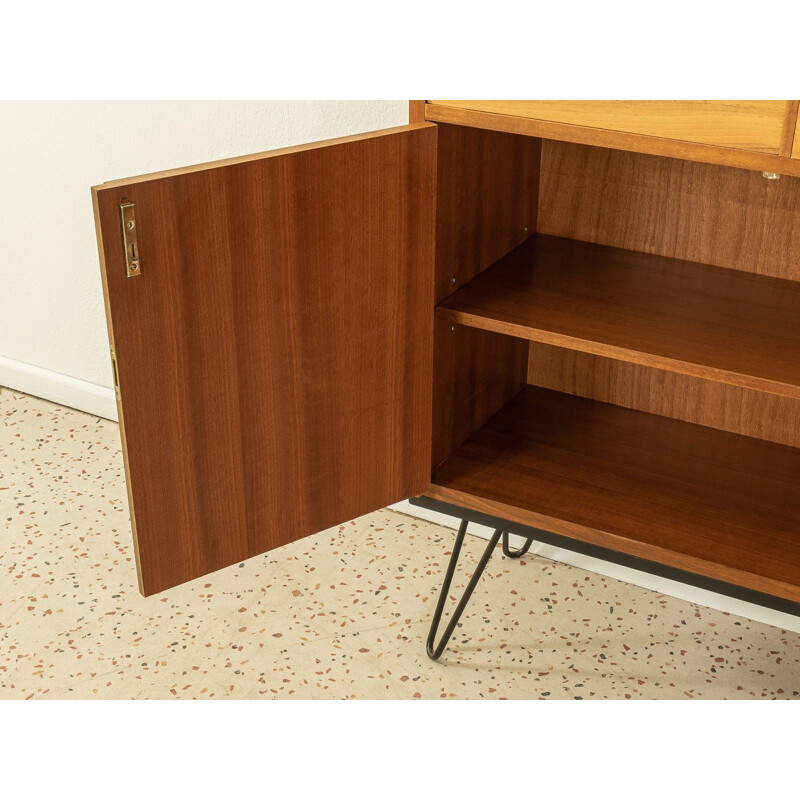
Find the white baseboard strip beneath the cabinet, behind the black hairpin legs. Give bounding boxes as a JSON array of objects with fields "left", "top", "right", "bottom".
[{"left": 390, "top": 500, "right": 800, "bottom": 633}]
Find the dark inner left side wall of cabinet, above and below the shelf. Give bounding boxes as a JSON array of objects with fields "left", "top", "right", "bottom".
[{"left": 432, "top": 125, "right": 541, "bottom": 468}]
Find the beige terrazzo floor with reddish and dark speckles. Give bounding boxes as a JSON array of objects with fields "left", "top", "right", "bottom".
[{"left": 0, "top": 389, "right": 800, "bottom": 699}]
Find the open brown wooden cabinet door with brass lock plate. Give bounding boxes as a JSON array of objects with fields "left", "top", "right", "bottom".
[{"left": 93, "top": 124, "right": 436, "bottom": 595}]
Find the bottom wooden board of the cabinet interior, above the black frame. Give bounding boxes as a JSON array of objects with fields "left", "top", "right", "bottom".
[{"left": 428, "top": 386, "right": 800, "bottom": 601}]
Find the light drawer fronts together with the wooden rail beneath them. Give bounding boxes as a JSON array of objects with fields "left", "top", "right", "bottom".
[{"left": 425, "top": 100, "right": 800, "bottom": 175}]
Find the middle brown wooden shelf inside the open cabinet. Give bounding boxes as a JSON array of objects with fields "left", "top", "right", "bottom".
[{"left": 437, "top": 234, "right": 800, "bottom": 398}]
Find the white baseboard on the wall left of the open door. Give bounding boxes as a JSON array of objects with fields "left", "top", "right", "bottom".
[{"left": 0, "top": 356, "right": 117, "bottom": 421}]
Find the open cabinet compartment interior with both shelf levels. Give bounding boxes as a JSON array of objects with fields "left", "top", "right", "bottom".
[{"left": 429, "top": 124, "right": 800, "bottom": 601}]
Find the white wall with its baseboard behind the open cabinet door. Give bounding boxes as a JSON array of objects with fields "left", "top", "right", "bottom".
[{"left": 0, "top": 100, "right": 408, "bottom": 418}]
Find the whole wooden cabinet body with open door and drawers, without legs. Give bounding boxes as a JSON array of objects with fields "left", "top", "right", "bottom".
[{"left": 94, "top": 101, "right": 800, "bottom": 620}]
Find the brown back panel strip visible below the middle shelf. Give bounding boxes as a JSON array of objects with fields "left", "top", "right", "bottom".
[{"left": 528, "top": 342, "right": 800, "bottom": 447}]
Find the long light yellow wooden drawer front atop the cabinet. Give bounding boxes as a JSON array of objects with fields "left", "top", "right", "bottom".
[{"left": 430, "top": 100, "right": 788, "bottom": 157}]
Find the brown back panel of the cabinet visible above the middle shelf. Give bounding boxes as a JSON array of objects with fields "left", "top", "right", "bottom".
[{"left": 537, "top": 142, "right": 800, "bottom": 280}]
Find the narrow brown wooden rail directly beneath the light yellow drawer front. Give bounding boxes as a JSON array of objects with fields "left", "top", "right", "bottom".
[{"left": 425, "top": 103, "right": 800, "bottom": 175}]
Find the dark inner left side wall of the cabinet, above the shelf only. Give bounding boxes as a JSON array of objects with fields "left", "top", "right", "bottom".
[{"left": 435, "top": 125, "right": 541, "bottom": 302}]
